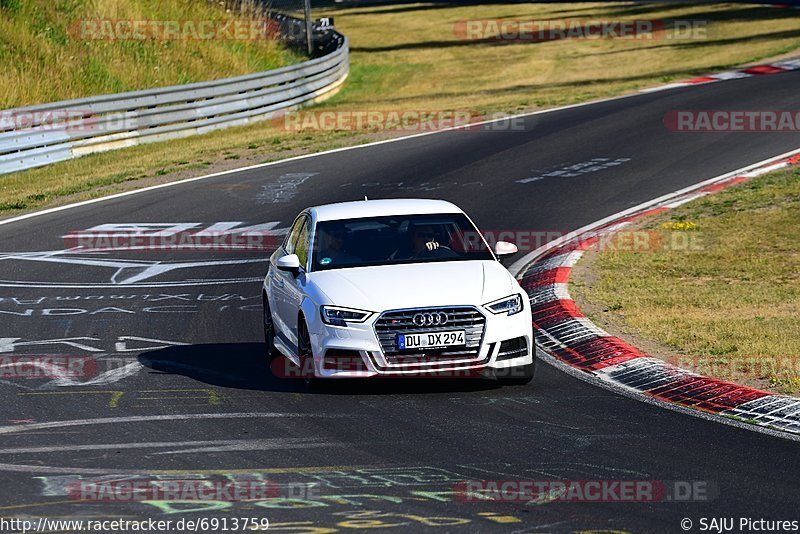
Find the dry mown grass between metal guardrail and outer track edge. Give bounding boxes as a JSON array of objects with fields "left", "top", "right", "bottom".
[{"left": 0, "top": 0, "right": 800, "bottom": 215}]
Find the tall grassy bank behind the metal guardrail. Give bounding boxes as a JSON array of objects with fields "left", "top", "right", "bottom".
[{"left": 0, "top": 0, "right": 300, "bottom": 109}]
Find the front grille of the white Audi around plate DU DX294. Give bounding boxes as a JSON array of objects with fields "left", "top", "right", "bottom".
[{"left": 375, "top": 306, "right": 486, "bottom": 366}]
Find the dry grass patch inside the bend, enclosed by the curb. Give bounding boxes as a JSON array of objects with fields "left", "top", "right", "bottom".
[{"left": 570, "top": 168, "right": 800, "bottom": 394}]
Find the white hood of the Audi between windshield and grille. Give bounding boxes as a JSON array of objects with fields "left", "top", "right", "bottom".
[{"left": 309, "top": 260, "right": 519, "bottom": 312}]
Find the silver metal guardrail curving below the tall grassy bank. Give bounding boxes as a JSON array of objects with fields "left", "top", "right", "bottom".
[{"left": 0, "top": 15, "right": 349, "bottom": 174}]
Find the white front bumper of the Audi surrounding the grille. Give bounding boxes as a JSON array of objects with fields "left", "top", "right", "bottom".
[{"left": 309, "top": 306, "right": 535, "bottom": 378}]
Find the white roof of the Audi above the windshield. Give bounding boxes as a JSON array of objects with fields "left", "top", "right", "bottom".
[{"left": 308, "top": 198, "right": 462, "bottom": 222}]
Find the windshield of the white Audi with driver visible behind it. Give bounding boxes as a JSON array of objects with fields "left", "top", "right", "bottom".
[{"left": 311, "top": 213, "right": 494, "bottom": 271}]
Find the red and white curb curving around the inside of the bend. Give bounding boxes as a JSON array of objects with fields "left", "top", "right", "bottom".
[{"left": 509, "top": 150, "right": 800, "bottom": 434}]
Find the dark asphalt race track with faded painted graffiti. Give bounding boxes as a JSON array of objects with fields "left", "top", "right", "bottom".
[{"left": 0, "top": 71, "right": 800, "bottom": 532}]
